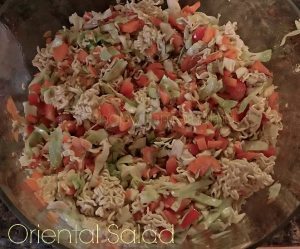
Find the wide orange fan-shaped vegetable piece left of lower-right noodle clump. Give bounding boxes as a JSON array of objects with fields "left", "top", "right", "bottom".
[{"left": 187, "top": 156, "right": 221, "bottom": 176}]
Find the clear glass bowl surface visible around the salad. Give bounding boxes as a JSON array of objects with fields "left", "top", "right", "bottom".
[{"left": 0, "top": 0, "right": 300, "bottom": 249}]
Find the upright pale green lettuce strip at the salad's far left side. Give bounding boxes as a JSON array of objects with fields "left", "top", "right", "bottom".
[{"left": 49, "top": 127, "right": 63, "bottom": 168}]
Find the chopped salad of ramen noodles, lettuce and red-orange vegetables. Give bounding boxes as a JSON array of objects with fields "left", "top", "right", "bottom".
[{"left": 9, "top": 0, "right": 282, "bottom": 243}]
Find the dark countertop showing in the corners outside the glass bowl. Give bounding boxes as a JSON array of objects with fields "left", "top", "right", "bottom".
[{"left": 0, "top": 0, "right": 300, "bottom": 249}]
